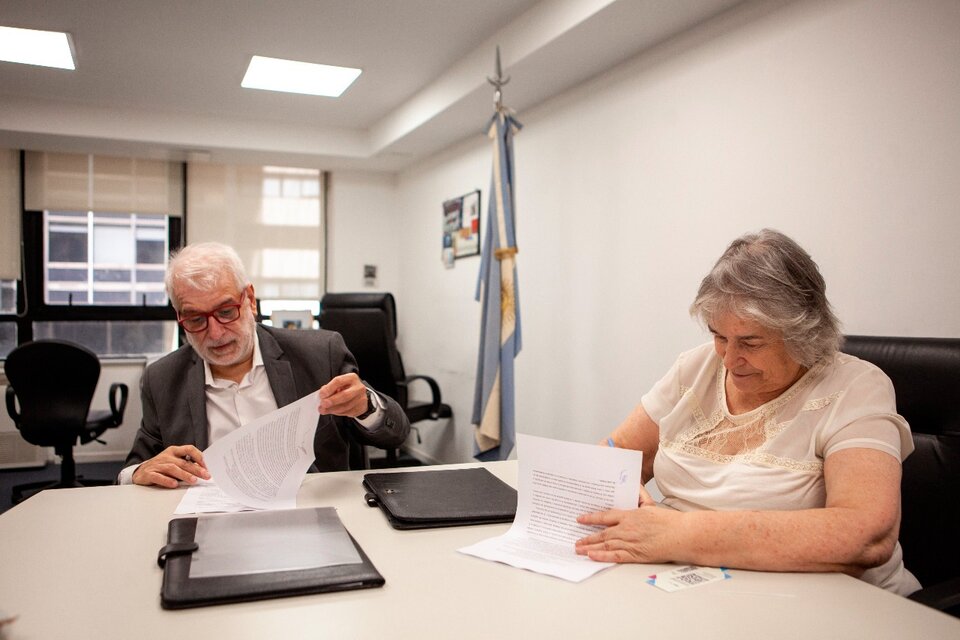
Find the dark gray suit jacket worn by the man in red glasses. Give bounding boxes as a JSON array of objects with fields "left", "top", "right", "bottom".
[{"left": 124, "top": 325, "right": 410, "bottom": 471}]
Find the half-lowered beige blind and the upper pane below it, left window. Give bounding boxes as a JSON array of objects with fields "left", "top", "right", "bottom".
[{"left": 24, "top": 152, "right": 183, "bottom": 306}]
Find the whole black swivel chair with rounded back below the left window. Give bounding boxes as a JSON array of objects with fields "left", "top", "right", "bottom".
[{"left": 4, "top": 340, "right": 128, "bottom": 504}]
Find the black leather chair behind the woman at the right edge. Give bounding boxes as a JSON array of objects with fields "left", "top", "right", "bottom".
[{"left": 843, "top": 336, "right": 960, "bottom": 617}]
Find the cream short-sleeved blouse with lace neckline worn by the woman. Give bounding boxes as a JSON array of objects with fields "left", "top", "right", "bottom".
[{"left": 641, "top": 343, "right": 920, "bottom": 594}]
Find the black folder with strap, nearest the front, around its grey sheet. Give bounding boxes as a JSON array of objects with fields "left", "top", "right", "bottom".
[{"left": 157, "top": 508, "right": 384, "bottom": 609}]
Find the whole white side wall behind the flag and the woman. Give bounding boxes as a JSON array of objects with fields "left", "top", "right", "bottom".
[{"left": 386, "top": 0, "right": 960, "bottom": 462}]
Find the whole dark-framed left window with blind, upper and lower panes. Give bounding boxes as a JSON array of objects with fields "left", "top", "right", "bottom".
[{"left": 10, "top": 152, "right": 184, "bottom": 357}]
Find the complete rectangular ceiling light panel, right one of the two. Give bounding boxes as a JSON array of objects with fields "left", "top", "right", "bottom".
[{"left": 240, "top": 56, "right": 360, "bottom": 98}]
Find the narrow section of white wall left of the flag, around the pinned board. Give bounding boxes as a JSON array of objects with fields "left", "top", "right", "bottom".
[{"left": 397, "top": 144, "right": 492, "bottom": 462}]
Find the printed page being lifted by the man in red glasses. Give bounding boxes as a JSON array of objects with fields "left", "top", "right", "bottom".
[{"left": 203, "top": 392, "right": 317, "bottom": 509}]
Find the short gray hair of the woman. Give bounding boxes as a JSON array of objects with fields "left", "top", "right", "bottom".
[{"left": 690, "top": 229, "right": 842, "bottom": 367}]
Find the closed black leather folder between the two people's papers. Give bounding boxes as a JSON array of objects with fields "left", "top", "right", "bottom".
[{"left": 363, "top": 467, "right": 517, "bottom": 529}]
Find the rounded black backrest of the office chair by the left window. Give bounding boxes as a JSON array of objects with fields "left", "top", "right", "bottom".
[{"left": 4, "top": 340, "right": 100, "bottom": 452}]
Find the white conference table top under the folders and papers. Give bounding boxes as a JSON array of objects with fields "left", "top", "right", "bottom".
[{"left": 0, "top": 462, "right": 960, "bottom": 640}]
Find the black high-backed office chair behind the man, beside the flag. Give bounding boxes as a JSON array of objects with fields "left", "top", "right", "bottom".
[{"left": 320, "top": 293, "right": 453, "bottom": 466}]
